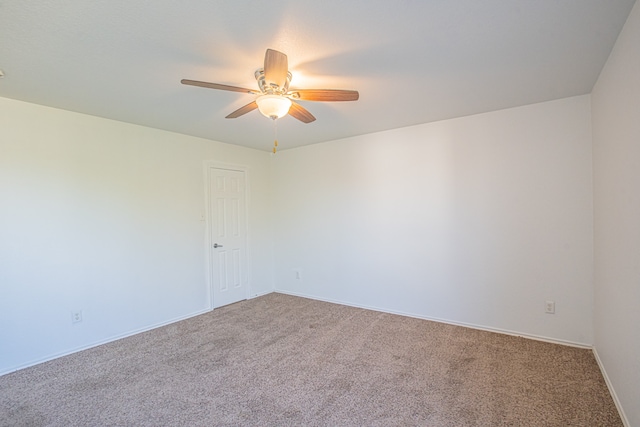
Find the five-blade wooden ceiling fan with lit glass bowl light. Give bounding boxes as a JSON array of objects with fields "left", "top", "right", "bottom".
[{"left": 181, "top": 49, "right": 360, "bottom": 123}]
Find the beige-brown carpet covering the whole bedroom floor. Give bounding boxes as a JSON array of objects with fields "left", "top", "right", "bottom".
[{"left": 0, "top": 294, "right": 622, "bottom": 426}]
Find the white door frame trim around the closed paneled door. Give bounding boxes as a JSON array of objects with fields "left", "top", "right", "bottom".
[{"left": 204, "top": 160, "right": 251, "bottom": 310}]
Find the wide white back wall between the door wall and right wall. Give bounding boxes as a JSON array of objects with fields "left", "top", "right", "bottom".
[{"left": 273, "top": 96, "right": 593, "bottom": 345}]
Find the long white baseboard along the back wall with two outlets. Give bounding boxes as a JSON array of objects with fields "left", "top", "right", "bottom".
[{"left": 275, "top": 290, "right": 592, "bottom": 349}]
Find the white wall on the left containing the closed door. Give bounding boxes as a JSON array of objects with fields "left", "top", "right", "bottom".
[{"left": 0, "top": 98, "right": 273, "bottom": 374}]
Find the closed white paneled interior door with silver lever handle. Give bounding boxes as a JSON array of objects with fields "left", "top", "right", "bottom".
[{"left": 209, "top": 167, "right": 249, "bottom": 308}]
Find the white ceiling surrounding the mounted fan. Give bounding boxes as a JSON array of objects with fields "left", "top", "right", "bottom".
[{"left": 0, "top": 0, "right": 635, "bottom": 151}]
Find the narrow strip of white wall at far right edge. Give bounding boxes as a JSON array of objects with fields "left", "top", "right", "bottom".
[{"left": 592, "top": 3, "right": 640, "bottom": 426}]
